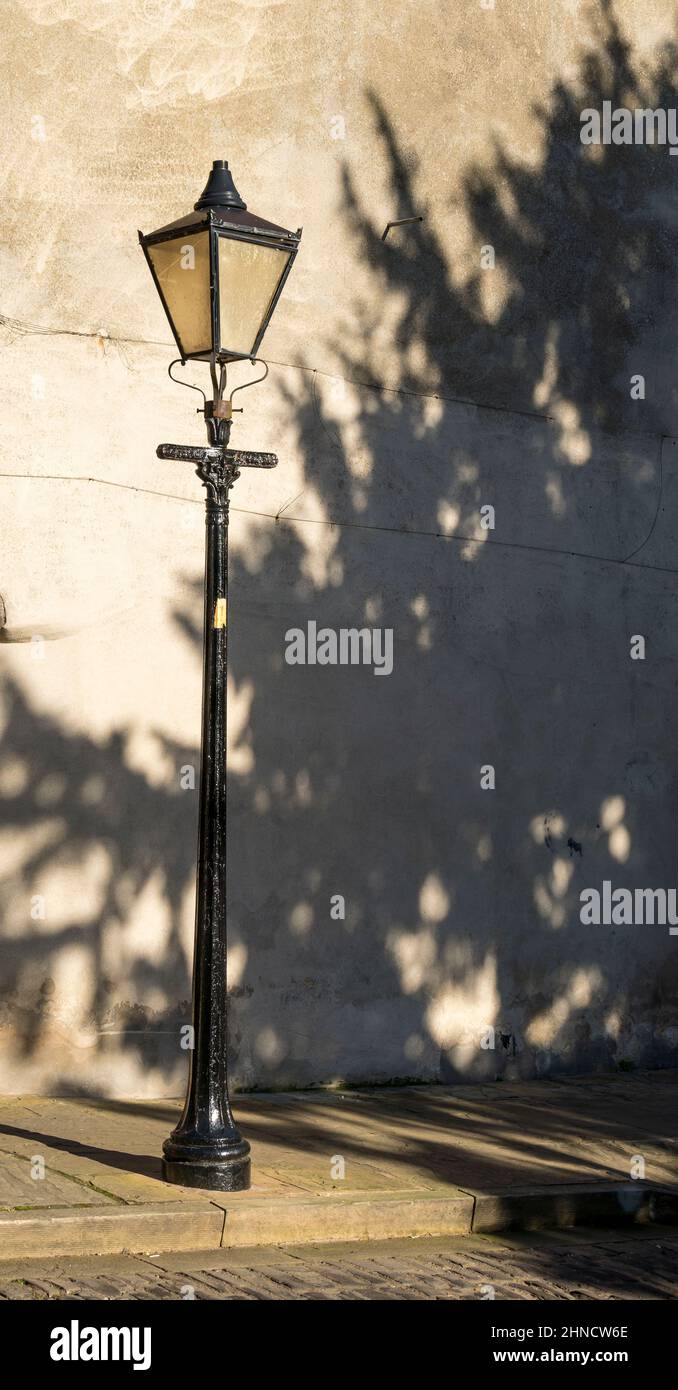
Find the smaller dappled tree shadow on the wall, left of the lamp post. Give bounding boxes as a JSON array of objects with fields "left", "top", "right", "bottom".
[{"left": 0, "top": 678, "right": 196, "bottom": 1090}]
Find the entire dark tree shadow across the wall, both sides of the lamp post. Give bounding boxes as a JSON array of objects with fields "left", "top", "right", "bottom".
[{"left": 1, "top": 4, "right": 678, "bottom": 1088}]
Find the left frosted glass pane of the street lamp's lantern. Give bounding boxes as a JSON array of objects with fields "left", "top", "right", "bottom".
[{"left": 147, "top": 231, "right": 213, "bottom": 357}]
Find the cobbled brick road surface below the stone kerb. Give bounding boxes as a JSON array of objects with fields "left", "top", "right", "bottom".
[{"left": 0, "top": 1229, "right": 678, "bottom": 1301}]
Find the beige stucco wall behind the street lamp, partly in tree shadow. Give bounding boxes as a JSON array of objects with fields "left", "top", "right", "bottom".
[{"left": 0, "top": 0, "right": 678, "bottom": 1095}]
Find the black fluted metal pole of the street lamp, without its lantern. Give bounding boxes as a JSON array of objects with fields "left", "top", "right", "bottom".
[{"left": 158, "top": 430, "right": 250, "bottom": 1193}]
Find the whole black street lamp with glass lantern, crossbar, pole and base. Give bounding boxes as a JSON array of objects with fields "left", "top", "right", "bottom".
[{"left": 139, "top": 160, "right": 301, "bottom": 1191}]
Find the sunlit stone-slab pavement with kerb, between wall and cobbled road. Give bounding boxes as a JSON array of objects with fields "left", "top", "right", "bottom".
[{"left": 0, "top": 1070, "right": 678, "bottom": 1259}]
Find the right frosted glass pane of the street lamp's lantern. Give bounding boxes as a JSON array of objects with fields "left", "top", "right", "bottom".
[{"left": 218, "top": 236, "right": 290, "bottom": 357}]
